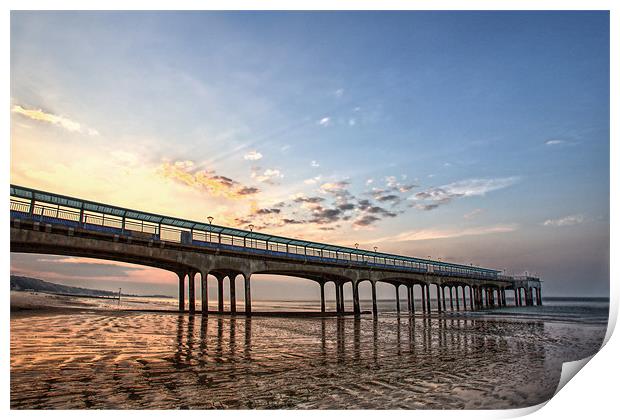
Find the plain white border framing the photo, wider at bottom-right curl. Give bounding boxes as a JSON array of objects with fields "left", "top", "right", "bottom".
[{"left": 0, "top": 0, "right": 620, "bottom": 419}]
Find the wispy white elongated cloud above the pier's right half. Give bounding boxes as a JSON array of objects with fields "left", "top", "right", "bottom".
[{"left": 409, "top": 177, "right": 519, "bottom": 210}]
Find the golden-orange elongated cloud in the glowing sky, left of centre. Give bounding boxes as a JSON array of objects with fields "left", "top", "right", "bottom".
[{"left": 157, "top": 160, "right": 259, "bottom": 199}]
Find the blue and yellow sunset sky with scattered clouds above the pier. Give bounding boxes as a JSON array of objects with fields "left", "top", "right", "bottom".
[{"left": 10, "top": 11, "right": 610, "bottom": 299}]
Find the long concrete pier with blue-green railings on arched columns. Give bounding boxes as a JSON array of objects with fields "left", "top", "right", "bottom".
[{"left": 10, "top": 185, "right": 542, "bottom": 315}]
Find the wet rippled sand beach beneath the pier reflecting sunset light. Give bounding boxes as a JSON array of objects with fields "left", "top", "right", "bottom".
[{"left": 11, "top": 310, "right": 605, "bottom": 409}]
